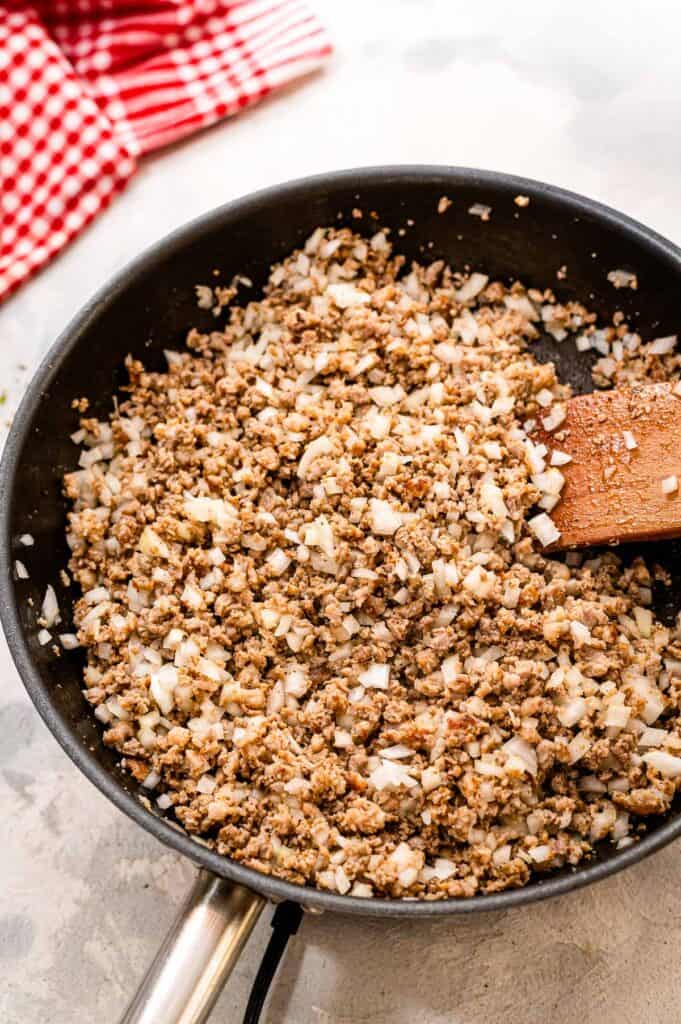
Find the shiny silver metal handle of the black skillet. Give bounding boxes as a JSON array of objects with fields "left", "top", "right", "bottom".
[{"left": 120, "top": 870, "right": 265, "bottom": 1024}]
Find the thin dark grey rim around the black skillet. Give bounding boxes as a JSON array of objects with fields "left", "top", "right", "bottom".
[{"left": 0, "top": 164, "right": 681, "bottom": 918}]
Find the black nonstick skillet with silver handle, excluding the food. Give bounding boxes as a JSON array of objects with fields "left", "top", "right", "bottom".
[{"left": 0, "top": 167, "right": 681, "bottom": 1024}]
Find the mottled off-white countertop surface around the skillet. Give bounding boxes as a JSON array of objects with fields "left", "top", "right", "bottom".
[{"left": 0, "top": 0, "right": 681, "bottom": 1024}]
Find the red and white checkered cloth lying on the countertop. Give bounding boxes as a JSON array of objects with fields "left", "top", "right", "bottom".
[{"left": 0, "top": 0, "right": 331, "bottom": 300}]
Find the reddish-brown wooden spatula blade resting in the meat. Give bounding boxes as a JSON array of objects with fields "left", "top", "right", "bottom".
[{"left": 533, "top": 383, "right": 681, "bottom": 551}]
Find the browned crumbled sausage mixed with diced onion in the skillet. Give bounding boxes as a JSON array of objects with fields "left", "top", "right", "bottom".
[{"left": 58, "top": 229, "right": 681, "bottom": 899}]
